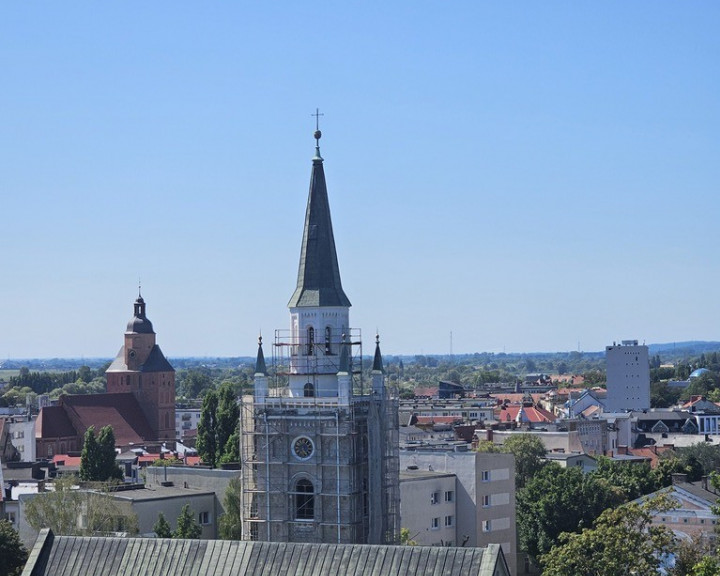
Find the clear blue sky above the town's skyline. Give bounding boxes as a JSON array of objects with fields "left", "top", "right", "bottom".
[{"left": 0, "top": 0, "right": 720, "bottom": 358}]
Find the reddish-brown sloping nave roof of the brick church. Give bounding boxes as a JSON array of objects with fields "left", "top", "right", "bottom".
[{"left": 60, "top": 392, "right": 157, "bottom": 446}]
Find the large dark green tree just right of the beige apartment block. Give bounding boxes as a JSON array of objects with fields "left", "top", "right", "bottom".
[{"left": 517, "top": 462, "right": 625, "bottom": 559}]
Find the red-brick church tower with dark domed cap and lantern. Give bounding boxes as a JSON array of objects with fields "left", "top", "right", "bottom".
[{"left": 105, "top": 293, "right": 175, "bottom": 442}]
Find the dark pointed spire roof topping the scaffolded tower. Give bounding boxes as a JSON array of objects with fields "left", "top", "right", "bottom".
[{"left": 288, "top": 130, "right": 350, "bottom": 308}]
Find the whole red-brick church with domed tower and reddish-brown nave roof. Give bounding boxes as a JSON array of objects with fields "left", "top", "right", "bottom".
[{"left": 35, "top": 294, "right": 175, "bottom": 458}]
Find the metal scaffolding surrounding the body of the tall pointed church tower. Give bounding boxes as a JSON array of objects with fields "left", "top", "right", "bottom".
[{"left": 240, "top": 330, "right": 400, "bottom": 543}]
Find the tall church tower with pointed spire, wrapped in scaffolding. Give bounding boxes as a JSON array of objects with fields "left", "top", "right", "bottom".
[{"left": 240, "top": 130, "right": 400, "bottom": 544}]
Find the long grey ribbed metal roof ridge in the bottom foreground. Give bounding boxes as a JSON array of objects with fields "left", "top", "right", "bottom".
[{"left": 23, "top": 529, "right": 509, "bottom": 576}]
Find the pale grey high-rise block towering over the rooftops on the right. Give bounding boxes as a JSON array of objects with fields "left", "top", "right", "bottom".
[{"left": 605, "top": 340, "right": 650, "bottom": 412}]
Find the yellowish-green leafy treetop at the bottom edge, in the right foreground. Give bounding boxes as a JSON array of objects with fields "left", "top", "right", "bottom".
[{"left": 541, "top": 497, "right": 674, "bottom": 576}]
